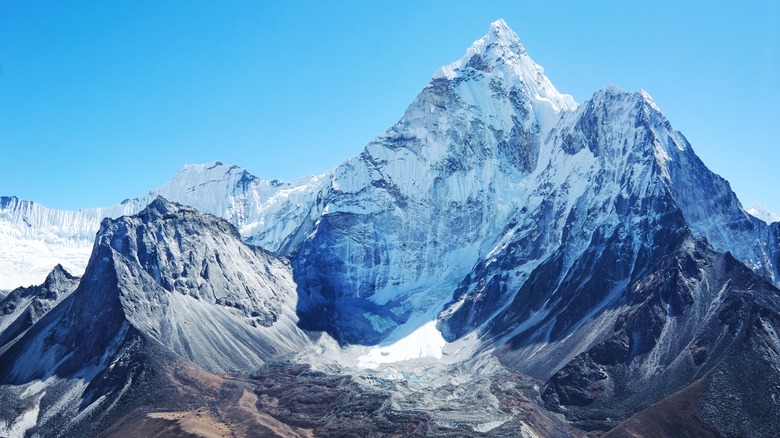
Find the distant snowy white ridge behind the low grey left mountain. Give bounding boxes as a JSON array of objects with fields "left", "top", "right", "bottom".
[{"left": 0, "top": 161, "right": 323, "bottom": 290}]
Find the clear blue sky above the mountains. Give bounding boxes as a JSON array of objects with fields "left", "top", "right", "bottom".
[{"left": 0, "top": 0, "right": 780, "bottom": 213}]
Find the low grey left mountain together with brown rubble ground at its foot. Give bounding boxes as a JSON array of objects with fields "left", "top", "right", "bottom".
[{"left": 0, "top": 198, "right": 580, "bottom": 437}]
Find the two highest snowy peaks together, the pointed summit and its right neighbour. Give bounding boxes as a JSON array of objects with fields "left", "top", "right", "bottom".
[{"left": 293, "top": 21, "right": 778, "bottom": 350}]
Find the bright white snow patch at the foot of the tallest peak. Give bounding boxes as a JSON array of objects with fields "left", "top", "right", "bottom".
[{"left": 358, "top": 321, "right": 447, "bottom": 368}]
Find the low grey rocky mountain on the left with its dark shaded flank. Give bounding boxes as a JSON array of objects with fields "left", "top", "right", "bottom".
[{"left": 0, "top": 198, "right": 308, "bottom": 434}]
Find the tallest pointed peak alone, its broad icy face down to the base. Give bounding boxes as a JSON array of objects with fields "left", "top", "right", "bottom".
[{"left": 294, "top": 17, "right": 576, "bottom": 344}]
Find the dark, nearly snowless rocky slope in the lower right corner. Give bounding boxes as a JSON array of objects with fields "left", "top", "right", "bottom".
[{"left": 540, "top": 237, "right": 780, "bottom": 436}]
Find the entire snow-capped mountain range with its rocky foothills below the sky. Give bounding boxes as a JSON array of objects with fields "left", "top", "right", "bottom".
[{"left": 0, "top": 20, "right": 780, "bottom": 437}]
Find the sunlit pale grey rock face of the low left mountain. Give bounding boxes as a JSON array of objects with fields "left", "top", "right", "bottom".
[{"left": 85, "top": 198, "right": 305, "bottom": 372}]
